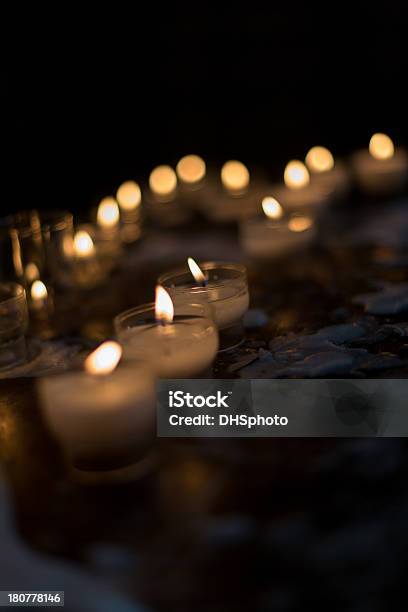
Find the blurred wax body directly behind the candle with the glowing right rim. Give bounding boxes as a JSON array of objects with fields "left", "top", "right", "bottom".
[{"left": 271, "top": 181, "right": 331, "bottom": 212}]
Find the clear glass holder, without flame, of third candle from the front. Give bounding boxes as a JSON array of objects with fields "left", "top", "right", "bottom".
[{"left": 157, "top": 261, "right": 249, "bottom": 351}]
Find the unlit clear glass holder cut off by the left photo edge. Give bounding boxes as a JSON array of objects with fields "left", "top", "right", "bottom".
[{"left": 0, "top": 283, "right": 28, "bottom": 370}]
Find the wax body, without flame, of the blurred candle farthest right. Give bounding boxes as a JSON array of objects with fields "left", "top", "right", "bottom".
[{"left": 351, "top": 148, "right": 408, "bottom": 194}]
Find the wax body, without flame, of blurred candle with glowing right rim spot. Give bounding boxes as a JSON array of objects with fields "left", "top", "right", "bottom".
[{"left": 240, "top": 217, "right": 316, "bottom": 259}]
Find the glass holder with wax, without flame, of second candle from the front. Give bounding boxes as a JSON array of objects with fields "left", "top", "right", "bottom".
[{"left": 114, "top": 302, "right": 218, "bottom": 378}]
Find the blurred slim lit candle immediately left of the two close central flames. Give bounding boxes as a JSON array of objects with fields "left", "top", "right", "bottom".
[{"left": 116, "top": 181, "right": 142, "bottom": 244}]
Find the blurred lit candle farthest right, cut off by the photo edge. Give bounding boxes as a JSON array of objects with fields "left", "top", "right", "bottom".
[{"left": 351, "top": 133, "right": 408, "bottom": 195}]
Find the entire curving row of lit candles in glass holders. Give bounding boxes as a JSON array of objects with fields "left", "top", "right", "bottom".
[{"left": 0, "top": 134, "right": 408, "bottom": 463}]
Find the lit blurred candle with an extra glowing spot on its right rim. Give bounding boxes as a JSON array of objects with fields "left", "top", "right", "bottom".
[{"left": 240, "top": 197, "right": 316, "bottom": 260}]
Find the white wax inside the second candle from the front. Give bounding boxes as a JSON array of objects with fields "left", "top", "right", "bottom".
[{"left": 118, "top": 317, "right": 218, "bottom": 378}]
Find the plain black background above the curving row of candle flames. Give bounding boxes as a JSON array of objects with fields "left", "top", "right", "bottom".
[{"left": 2, "top": 2, "right": 408, "bottom": 214}]
